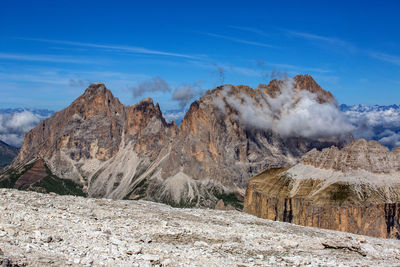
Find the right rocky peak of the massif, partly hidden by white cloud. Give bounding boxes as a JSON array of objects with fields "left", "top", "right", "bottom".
[{"left": 162, "top": 75, "right": 343, "bottom": 188}]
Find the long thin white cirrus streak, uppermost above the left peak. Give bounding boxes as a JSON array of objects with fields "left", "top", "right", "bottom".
[{"left": 18, "top": 38, "right": 195, "bottom": 58}]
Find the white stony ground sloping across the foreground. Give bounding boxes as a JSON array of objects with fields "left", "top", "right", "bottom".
[{"left": 0, "top": 189, "right": 400, "bottom": 266}]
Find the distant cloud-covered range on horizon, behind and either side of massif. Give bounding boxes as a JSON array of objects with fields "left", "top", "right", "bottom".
[{"left": 0, "top": 104, "right": 400, "bottom": 148}]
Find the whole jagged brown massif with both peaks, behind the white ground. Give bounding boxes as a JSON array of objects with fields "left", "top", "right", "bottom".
[{"left": 0, "top": 75, "right": 345, "bottom": 209}]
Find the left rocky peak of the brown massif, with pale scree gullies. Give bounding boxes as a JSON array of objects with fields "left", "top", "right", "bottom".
[{"left": 10, "top": 83, "right": 177, "bottom": 201}]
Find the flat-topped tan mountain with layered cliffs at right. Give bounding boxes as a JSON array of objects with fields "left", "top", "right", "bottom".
[{"left": 244, "top": 139, "right": 400, "bottom": 239}]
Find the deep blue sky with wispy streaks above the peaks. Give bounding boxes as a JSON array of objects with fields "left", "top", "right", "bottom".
[{"left": 0, "top": 0, "right": 400, "bottom": 110}]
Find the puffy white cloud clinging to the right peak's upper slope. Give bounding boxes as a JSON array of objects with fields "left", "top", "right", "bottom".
[{"left": 215, "top": 77, "right": 355, "bottom": 139}]
